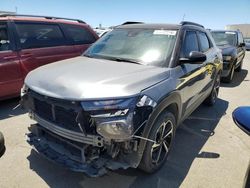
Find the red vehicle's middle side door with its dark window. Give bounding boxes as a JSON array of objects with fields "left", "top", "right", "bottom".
[{"left": 15, "top": 22, "right": 77, "bottom": 76}]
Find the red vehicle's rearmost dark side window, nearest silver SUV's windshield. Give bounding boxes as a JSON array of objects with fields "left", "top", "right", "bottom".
[{"left": 64, "top": 24, "right": 96, "bottom": 45}]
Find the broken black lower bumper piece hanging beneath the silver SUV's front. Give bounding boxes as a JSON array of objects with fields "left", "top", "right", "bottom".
[{"left": 27, "top": 124, "right": 134, "bottom": 177}]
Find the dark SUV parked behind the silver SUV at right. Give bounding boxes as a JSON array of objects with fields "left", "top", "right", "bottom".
[{"left": 211, "top": 30, "right": 246, "bottom": 83}]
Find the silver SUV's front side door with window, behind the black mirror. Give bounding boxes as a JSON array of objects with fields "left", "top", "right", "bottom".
[{"left": 177, "top": 30, "right": 210, "bottom": 116}]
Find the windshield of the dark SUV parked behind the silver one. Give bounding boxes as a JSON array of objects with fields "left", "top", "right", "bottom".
[{"left": 212, "top": 31, "right": 237, "bottom": 46}]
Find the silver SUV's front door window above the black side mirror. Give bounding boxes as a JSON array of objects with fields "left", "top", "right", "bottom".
[{"left": 181, "top": 31, "right": 199, "bottom": 58}]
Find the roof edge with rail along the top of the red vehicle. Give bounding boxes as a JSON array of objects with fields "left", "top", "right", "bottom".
[{"left": 0, "top": 15, "right": 88, "bottom": 25}]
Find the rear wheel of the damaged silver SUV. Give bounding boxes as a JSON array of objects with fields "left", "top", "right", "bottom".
[{"left": 204, "top": 73, "right": 220, "bottom": 106}]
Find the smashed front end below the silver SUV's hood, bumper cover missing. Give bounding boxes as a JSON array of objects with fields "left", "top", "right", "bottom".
[{"left": 21, "top": 89, "right": 155, "bottom": 177}]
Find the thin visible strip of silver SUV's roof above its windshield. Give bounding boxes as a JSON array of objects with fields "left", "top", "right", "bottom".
[{"left": 116, "top": 23, "right": 182, "bottom": 30}]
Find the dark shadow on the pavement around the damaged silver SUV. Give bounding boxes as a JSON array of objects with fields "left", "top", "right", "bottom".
[{"left": 28, "top": 99, "right": 228, "bottom": 188}]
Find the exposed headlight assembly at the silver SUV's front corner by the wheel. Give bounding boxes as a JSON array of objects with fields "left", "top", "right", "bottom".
[{"left": 81, "top": 95, "right": 156, "bottom": 140}]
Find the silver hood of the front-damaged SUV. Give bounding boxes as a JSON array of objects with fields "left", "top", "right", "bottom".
[{"left": 25, "top": 56, "right": 169, "bottom": 100}]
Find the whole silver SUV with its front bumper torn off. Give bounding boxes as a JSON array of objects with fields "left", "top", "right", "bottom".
[{"left": 21, "top": 22, "right": 222, "bottom": 176}]
